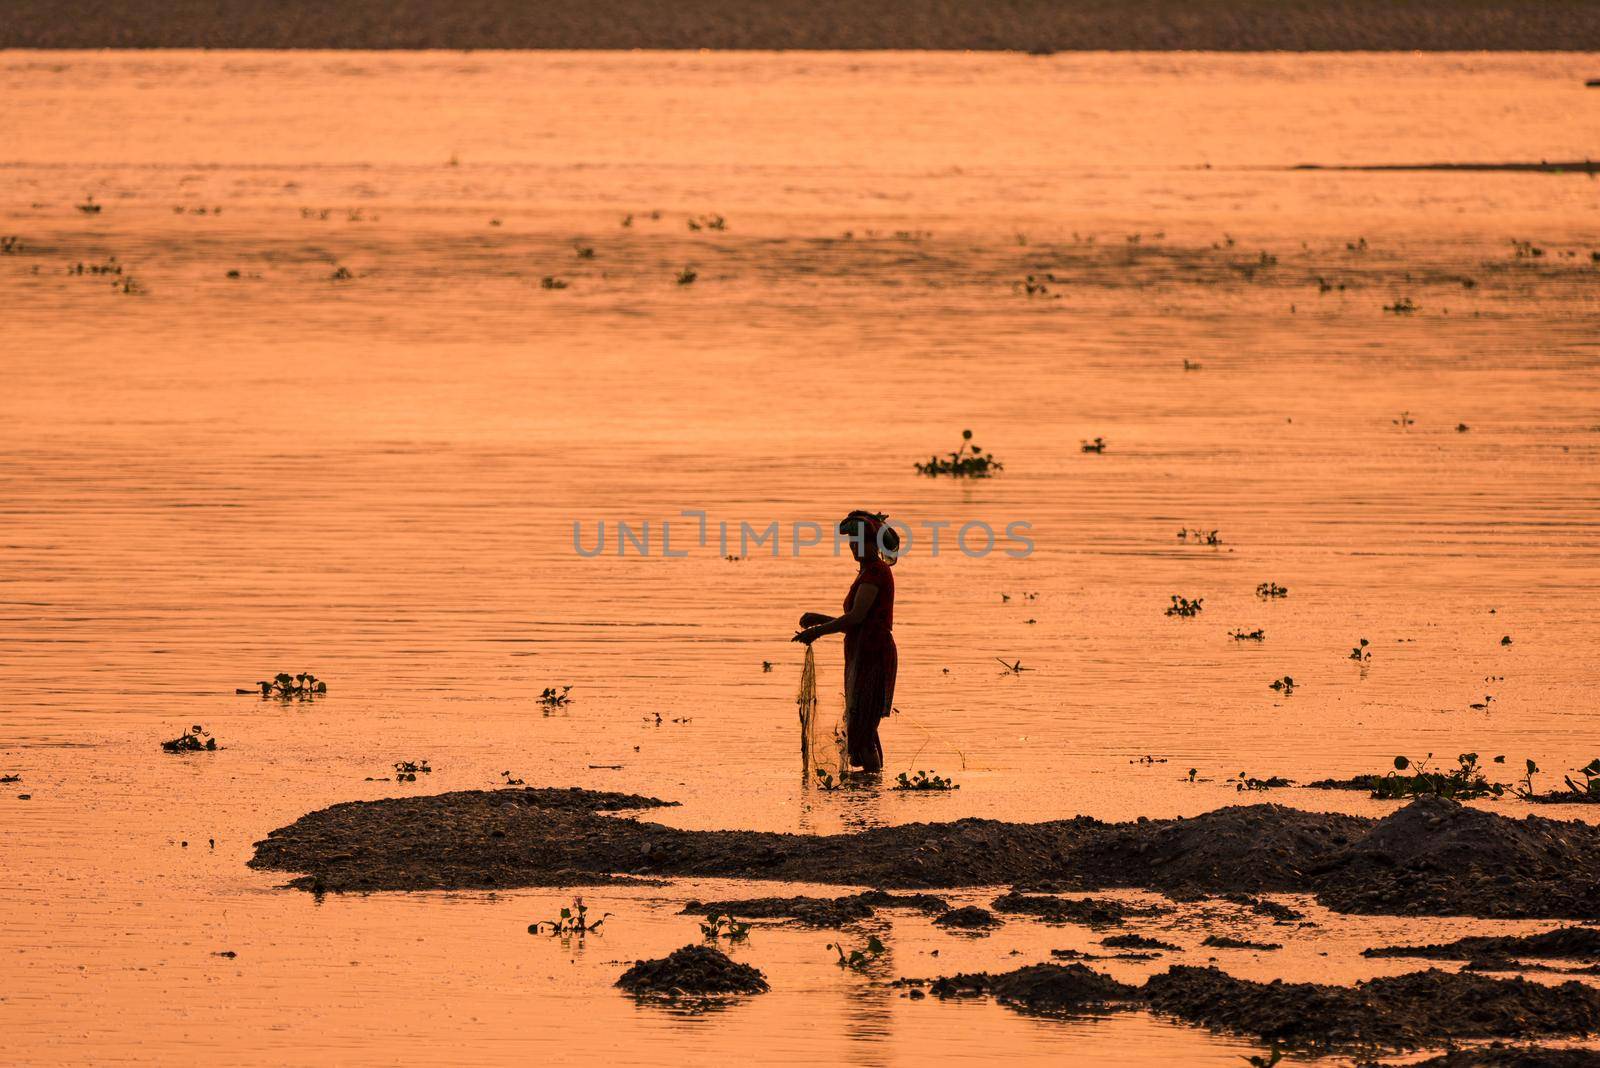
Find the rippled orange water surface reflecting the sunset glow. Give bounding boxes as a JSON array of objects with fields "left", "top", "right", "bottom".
[{"left": 0, "top": 53, "right": 1600, "bottom": 1065}]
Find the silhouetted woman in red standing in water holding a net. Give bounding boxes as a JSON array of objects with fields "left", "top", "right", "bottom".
[{"left": 794, "top": 510, "right": 899, "bottom": 771}]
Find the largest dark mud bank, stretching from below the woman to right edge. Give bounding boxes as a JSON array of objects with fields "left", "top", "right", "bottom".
[{"left": 250, "top": 788, "right": 1600, "bottom": 919}]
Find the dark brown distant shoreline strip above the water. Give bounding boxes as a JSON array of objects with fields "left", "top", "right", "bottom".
[{"left": 0, "top": 0, "right": 1600, "bottom": 51}]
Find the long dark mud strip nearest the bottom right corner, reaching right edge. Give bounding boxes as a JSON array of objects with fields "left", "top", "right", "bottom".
[{"left": 1144, "top": 966, "right": 1600, "bottom": 1049}]
